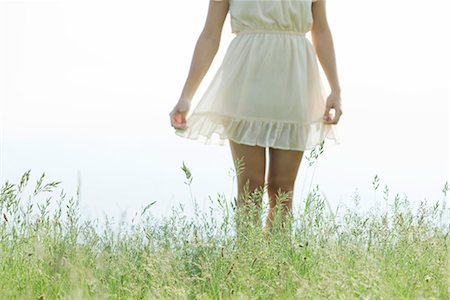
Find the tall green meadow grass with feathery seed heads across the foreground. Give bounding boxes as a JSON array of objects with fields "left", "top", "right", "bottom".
[{"left": 0, "top": 168, "right": 450, "bottom": 299}]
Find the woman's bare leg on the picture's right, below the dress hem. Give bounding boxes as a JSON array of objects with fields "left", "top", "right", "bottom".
[{"left": 265, "top": 147, "right": 303, "bottom": 230}]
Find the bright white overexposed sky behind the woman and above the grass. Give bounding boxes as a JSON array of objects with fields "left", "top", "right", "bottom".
[{"left": 0, "top": 0, "right": 450, "bottom": 225}]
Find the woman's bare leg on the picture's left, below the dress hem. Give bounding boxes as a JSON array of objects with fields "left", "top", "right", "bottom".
[{"left": 229, "top": 140, "right": 266, "bottom": 226}]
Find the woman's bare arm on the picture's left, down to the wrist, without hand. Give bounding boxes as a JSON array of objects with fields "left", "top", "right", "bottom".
[{"left": 181, "top": 0, "right": 228, "bottom": 101}]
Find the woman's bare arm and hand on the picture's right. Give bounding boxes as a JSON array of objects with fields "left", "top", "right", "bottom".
[{"left": 311, "top": 0, "right": 342, "bottom": 124}]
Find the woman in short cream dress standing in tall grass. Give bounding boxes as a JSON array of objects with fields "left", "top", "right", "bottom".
[{"left": 170, "top": 0, "right": 342, "bottom": 231}]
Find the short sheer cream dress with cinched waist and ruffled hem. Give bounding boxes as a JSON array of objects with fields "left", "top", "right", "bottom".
[{"left": 175, "top": 0, "right": 340, "bottom": 151}]
